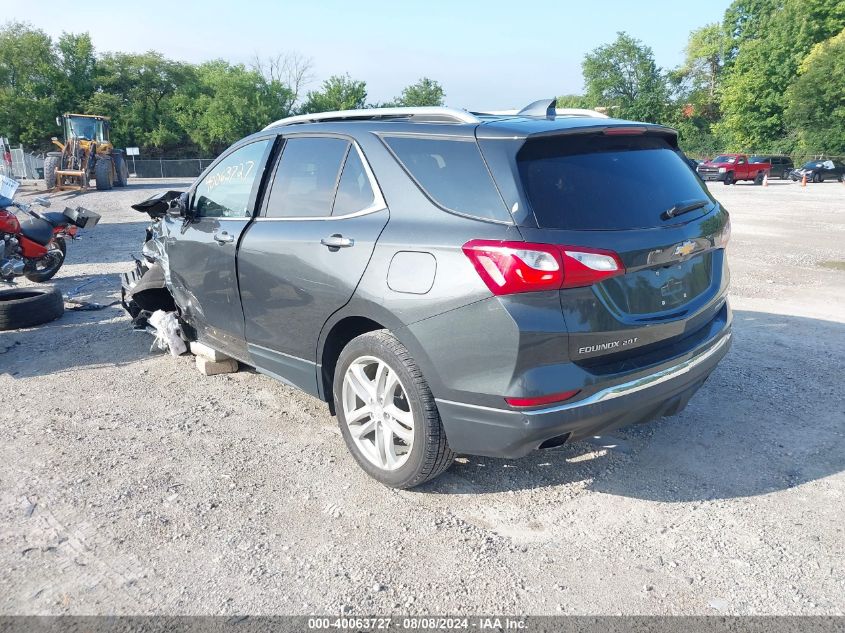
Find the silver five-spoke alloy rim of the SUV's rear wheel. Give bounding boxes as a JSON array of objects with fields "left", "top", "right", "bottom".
[{"left": 342, "top": 356, "right": 414, "bottom": 470}]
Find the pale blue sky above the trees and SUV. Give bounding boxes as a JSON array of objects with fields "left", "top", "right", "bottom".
[{"left": 0, "top": 0, "right": 730, "bottom": 110}]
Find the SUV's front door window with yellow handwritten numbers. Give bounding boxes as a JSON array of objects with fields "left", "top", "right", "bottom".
[{"left": 194, "top": 139, "right": 271, "bottom": 218}]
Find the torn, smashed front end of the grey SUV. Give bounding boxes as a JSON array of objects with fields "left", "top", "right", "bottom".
[{"left": 120, "top": 191, "right": 187, "bottom": 330}]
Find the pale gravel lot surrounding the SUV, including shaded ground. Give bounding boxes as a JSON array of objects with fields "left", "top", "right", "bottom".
[{"left": 0, "top": 180, "right": 845, "bottom": 614}]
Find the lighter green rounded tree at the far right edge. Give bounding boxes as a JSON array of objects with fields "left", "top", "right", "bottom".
[{"left": 786, "top": 30, "right": 845, "bottom": 155}]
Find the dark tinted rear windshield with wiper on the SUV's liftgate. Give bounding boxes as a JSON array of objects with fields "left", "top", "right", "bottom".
[{"left": 517, "top": 134, "right": 713, "bottom": 230}]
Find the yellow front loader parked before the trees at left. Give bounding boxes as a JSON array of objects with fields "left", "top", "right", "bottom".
[{"left": 44, "top": 114, "right": 129, "bottom": 191}]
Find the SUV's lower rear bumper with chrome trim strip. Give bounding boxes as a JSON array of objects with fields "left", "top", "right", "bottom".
[{"left": 437, "top": 326, "right": 731, "bottom": 457}]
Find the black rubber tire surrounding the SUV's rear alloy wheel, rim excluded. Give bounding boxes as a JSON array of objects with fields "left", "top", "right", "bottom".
[{"left": 333, "top": 330, "right": 455, "bottom": 488}]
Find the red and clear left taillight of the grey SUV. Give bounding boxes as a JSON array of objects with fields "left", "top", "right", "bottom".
[{"left": 463, "top": 240, "right": 625, "bottom": 295}]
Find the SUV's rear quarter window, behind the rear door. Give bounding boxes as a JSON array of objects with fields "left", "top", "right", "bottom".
[{"left": 384, "top": 136, "right": 512, "bottom": 222}]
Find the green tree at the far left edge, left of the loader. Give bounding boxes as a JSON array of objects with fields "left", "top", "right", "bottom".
[{"left": 0, "top": 22, "right": 59, "bottom": 149}]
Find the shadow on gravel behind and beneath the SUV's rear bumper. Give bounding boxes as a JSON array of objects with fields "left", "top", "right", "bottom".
[{"left": 417, "top": 311, "right": 845, "bottom": 502}]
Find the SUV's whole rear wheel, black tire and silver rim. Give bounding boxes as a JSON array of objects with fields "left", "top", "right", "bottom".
[{"left": 333, "top": 330, "right": 455, "bottom": 488}]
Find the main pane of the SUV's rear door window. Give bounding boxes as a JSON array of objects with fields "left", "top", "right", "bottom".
[{"left": 267, "top": 137, "right": 349, "bottom": 218}]
